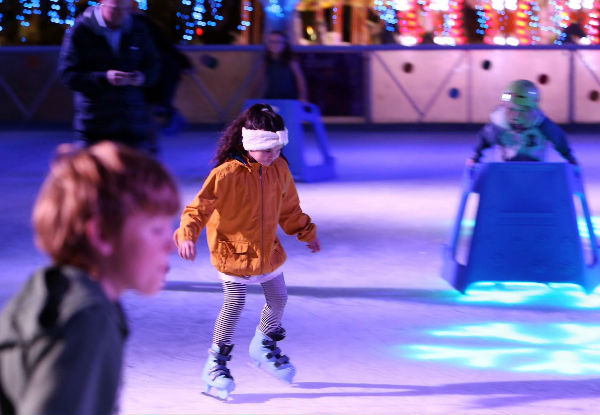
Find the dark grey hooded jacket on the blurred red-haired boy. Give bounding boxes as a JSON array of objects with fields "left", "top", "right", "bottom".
[{"left": 0, "top": 267, "right": 128, "bottom": 414}]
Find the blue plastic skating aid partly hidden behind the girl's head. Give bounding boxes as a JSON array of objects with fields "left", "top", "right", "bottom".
[{"left": 244, "top": 99, "right": 335, "bottom": 182}]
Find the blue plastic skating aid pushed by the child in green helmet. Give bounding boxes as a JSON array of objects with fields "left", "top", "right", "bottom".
[{"left": 442, "top": 162, "right": 600, "bottom": 293}]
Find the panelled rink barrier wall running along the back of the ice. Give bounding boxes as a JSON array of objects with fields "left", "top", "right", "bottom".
[{"left": 0, "top": 45, "right": 600, "bottom": 124}]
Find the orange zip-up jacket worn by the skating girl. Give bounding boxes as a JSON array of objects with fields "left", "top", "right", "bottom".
[{"left": 174, "top": 157, "right": 317, "bottom": 276}]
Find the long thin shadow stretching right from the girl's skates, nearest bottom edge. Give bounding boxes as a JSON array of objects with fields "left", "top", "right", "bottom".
[{"left": 231, "top": 379, "right": 600, "bottom": 409}]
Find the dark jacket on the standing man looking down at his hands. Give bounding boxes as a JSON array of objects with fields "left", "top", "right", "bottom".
[{"left": 58, "top": 7, "right": 160, "bottom": 144}]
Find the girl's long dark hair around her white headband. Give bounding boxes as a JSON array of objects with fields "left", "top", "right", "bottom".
[{"left": 213, "top": 104, "right": 285, "bottom": 166}]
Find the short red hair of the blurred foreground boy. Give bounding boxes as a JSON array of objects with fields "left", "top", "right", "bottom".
[{"left": 32, "top": 141, "right": 179, "bottom": 271}]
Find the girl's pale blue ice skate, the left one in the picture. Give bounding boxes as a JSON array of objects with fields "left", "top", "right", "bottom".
[{"left": 202, "top": 343, "right": 235, "bottom": 400}]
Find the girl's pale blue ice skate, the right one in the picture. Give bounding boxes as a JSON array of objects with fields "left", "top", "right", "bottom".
[{"left": 250, "top": 328, "right": 296, "bottom": 383}]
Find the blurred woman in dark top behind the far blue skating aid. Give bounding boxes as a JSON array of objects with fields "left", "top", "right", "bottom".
[{"left": 263, "top": 31, "right": 308, "bottom": 101}]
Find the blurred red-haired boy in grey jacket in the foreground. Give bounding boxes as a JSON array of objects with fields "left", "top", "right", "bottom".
[{"left": 0, "top": 142, "right": 179, "bottom": 414}]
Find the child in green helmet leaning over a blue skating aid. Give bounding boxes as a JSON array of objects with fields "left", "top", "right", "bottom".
[{"left": 467, "top": 79, "right": 577, "bottom": 167}]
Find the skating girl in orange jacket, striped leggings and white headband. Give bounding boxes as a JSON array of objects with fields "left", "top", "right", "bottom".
[{"left": 174, "top": 104, "right": 321, "bottom": 399}]
